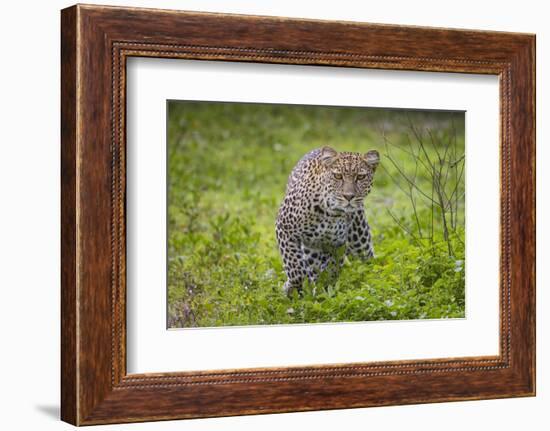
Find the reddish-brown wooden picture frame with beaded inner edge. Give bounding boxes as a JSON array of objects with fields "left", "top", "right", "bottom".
[{"left": 61, "top": 5, "right": 535, "bottom": 425}]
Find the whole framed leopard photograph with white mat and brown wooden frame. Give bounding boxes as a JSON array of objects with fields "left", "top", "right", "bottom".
[{"left": 61, "top": 5, "right": 535, "bottom": 425}]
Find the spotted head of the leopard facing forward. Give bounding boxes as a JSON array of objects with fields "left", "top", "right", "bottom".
[{"left": 320, "top": 147, "right": 380, "bottom": 213}]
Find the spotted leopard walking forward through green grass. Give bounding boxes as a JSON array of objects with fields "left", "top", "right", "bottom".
[{"left": 275, "top": 146, "right": 380, "bottom": 296}]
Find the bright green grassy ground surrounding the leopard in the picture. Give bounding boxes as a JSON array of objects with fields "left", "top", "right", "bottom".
[{"left": 168, "top": 102, "right": 465, "bottom": 327}]
